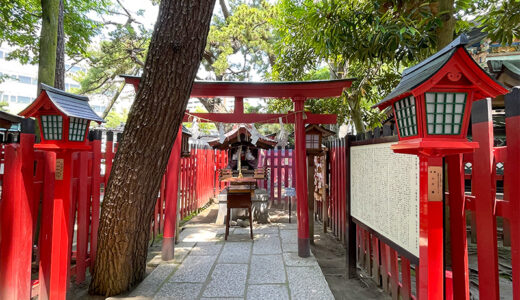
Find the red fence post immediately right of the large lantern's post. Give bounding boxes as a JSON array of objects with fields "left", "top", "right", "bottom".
[{"left": 446, "top": 154, "right": 469, "bottom": 300}]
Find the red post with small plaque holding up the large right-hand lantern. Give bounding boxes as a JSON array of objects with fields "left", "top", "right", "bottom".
[{"left": 418, "top": 155, "right": 444, "bottom": 300}]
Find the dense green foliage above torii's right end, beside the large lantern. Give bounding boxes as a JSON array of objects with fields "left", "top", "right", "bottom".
[{"left": 270, "top": 0, "right": 450, "bottom": 132}]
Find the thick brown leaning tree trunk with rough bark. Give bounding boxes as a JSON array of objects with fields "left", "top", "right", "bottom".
[{"left": 90, "top": 0, "right": 215, "bottom": 296}]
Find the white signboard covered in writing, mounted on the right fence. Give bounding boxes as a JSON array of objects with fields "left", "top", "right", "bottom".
[{"left": 350, "top": 143, "right": 419, "bottom": 257}]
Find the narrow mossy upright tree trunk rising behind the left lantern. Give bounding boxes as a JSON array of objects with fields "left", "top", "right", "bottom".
[{"left": 38, "top": 0, "right": 60, "bottom": 94}]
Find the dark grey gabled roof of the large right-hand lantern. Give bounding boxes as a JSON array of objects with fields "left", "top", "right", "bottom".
[{"left": 374, "top": 34, "right": 507, "bottom": 109}]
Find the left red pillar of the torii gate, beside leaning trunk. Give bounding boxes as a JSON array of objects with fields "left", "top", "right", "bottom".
[{"left": 162, "top": 126, "right": 182, "bottom": 260}]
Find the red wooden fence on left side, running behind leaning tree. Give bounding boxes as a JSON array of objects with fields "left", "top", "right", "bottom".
[{"left": 0, "top": 127, "right": 223, "bottom": 299}]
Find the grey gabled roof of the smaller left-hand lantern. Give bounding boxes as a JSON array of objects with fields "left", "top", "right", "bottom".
[{"left": 19, "top": 83, "right": 104, "bottom": 123}]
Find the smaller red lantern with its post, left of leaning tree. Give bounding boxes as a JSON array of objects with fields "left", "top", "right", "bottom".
[{"left": 20, "top": 84, "right": 103, "bottom": 299}]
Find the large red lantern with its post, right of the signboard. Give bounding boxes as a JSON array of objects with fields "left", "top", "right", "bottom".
[{"left": 376, "top": 35, "right": 507, "bottom": 299}]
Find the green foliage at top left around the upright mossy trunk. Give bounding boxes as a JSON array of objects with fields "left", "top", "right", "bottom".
[{"left": 0, "top": 0, "right": 110, "bottom": 63}]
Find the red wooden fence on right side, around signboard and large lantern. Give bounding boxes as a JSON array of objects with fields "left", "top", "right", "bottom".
[{"left": 327, "top": 88, "right": 520, "bottom": 300}]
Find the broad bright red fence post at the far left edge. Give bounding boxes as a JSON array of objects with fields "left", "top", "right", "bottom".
[{"left": 0, "top": 119, "right": 34, "bottom": 300}]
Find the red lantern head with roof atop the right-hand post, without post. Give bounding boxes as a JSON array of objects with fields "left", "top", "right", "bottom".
[{"left": 374, "top": 35, "right": 508, "bottom": 156}]
